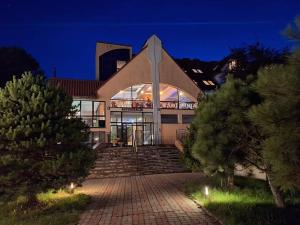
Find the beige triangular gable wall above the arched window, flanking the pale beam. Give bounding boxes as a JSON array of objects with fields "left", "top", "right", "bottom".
[{"left": 97, "top": 37, "right": 203, "bottom": 100}]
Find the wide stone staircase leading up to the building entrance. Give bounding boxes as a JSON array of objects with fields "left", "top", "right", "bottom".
[{"left": 88, "top": 146, "right": 188, "bottom": 179}]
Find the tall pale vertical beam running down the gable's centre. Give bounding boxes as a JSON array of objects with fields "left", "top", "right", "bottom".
[{"left": 146, "top": 35, "right": 162, "bottom": 144}]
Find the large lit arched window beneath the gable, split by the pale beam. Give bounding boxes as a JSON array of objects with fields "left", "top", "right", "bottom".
[{"left": 110, "top": 84, "right": 196, "bottom": 109}]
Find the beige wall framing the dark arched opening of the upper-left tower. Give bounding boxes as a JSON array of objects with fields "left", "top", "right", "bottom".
[{"left": 95, "top": 42, "right": 132, "bottom": 80}]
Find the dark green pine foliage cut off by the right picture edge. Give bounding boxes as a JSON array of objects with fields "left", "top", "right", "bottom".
[{"left": 249, "top": 51, "right": 300, "bottom": 189}]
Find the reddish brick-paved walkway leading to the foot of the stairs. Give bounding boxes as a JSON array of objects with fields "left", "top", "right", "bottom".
[{"left": 79, "top": 173, "right": 219, "bottom": 225}]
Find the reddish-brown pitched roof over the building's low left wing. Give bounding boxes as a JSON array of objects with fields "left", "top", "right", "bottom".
[{"left": 49, "top": 77, "right": 102, "bottom": 98}]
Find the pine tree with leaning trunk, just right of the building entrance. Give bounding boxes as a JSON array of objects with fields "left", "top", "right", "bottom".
[{"left": 193, "top": 76, "right": 284, "bottom": 207}]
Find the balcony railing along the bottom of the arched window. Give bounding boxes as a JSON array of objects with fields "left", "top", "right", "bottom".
[{"left": 110, "top": 100, "right": 197, "bottom": 109}]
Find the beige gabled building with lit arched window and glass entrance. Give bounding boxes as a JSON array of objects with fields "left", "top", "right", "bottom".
[{"left": 50, "top": 35, "right": 214, "bottom": 146}]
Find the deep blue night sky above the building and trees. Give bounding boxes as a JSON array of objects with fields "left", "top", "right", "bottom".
[{"left": 0, "top": 0, "right": 300, "bottom": 79}]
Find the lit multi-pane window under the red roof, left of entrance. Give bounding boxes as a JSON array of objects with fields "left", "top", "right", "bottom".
[{"left": 72, "top": 100, "right": 105, "bottom": 128}]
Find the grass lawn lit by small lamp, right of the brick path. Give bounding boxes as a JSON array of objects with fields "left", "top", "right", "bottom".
[{"left": 185, "top": 177, "right": 300, "bottom": 225}]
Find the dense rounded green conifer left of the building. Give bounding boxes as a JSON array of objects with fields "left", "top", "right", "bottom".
[{"left": 0, "top": 73, "right": 94, "bottom": 201}]
